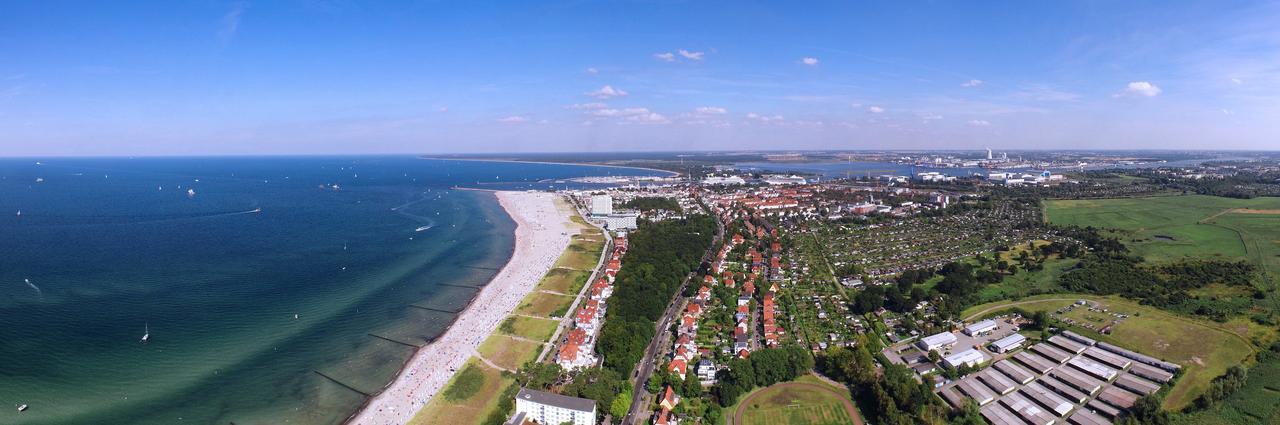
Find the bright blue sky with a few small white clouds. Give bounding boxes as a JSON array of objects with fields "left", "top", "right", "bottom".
[{"left": 0, "top": 0, "right": 1280, "bottom": 155}]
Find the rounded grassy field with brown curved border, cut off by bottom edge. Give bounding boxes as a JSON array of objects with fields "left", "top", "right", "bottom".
[{"left": 726, "top": 375, "right": 861, "bottom": 425}]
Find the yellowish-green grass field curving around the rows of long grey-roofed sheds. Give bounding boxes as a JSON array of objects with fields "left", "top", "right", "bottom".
[{"left": 961, "top": 294, "right": 1253, "bottom": 410}]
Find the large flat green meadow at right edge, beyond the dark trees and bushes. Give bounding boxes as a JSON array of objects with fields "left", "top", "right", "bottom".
[{"left": 1044, "top": 195, "right": 1280, "bottom": 275}]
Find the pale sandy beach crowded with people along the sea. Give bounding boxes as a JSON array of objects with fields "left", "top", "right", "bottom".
[{"left": 348, "top": 192, "right": 573, "bottom": 425}]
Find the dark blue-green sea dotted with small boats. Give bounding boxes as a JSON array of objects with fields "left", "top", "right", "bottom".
[{"left": 0, "top": 156, "right": 666, "bottom": 424}]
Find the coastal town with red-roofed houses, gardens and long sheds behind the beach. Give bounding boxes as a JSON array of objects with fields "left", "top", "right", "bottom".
[{"left": 381, "top": 151, "right": 1280, "bottom": 425}]
